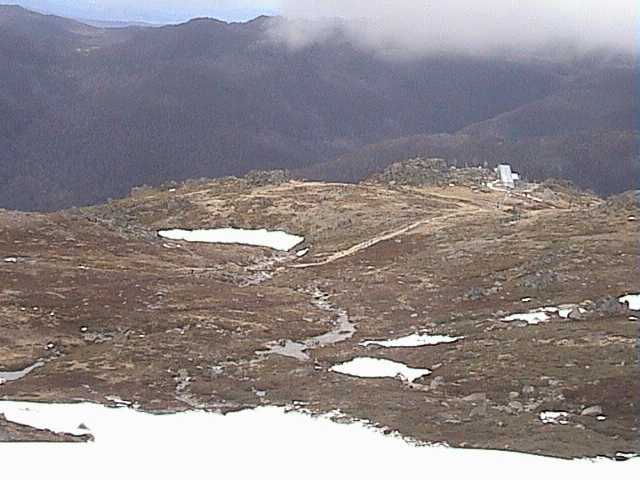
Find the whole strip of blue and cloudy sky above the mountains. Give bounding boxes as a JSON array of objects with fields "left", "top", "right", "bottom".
[{"left": 8, "top": 0, "right": 640, "bottom": 52}]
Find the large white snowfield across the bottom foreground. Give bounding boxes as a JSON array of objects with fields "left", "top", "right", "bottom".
[{"left": 0, "top": 402, "right": 640, "bottom": 480}]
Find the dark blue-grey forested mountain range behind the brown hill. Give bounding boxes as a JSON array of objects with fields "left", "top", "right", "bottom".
[{"left": 0, "top": 6, "right": 640, "bottom": 210}]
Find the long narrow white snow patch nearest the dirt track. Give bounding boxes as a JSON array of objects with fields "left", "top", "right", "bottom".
[{"left": 158, "top": 228, "right": 304, "bottom": 252}]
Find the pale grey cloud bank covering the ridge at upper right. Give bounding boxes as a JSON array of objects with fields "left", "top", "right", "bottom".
[{"left": 272, "top": 0, "right": 640, "bottom": 56}]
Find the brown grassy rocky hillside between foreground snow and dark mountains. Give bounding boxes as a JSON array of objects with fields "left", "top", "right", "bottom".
[{"left": 0, "top": 165, "right": 640, "bottom": 457}]
